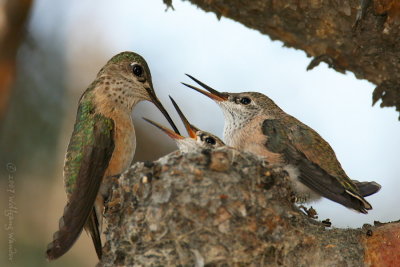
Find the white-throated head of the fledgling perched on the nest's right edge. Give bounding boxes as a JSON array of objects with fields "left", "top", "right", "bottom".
[{"left": 183, "top": 74, "right": 283, "bottom": 121}]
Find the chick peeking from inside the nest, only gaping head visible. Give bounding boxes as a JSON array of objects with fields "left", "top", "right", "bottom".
[{"left": 143, "top": 96, "right": 225, "bottom": 153}]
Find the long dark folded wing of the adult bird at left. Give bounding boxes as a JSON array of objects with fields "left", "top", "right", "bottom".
[{"left": 46, "top": 113, "right": 114, "bottom": 260}]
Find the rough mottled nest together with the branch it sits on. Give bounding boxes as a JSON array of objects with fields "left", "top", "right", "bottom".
[{"left": 99, "top": 148, "right": 400, "bottom": 267}]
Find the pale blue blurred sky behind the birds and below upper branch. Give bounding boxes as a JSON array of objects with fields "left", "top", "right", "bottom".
[{"left": 31, "top": 0, "right": 400, "bottom": 227}]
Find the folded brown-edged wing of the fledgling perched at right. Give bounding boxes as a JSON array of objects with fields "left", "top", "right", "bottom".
[{"left": 262, "top": 117, "right": 372, "bottom": 213}]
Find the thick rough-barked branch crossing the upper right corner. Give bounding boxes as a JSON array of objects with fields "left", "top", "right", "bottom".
[{"left": 184, "top": 0, "right": 400, "bottom": 118}]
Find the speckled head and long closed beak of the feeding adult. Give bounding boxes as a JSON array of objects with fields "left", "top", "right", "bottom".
[{"left": 97, "top": 52, "right": 179, "bottom": 133}]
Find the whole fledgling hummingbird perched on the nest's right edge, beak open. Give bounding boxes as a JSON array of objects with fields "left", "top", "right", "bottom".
[{"left": 183, "top": 75, "right": 381, "bottom": 213}]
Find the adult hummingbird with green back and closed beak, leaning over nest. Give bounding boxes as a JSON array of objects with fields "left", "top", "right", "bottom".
[{"left": 46, "top": 52, "right": 179, "bottom": 260}]
